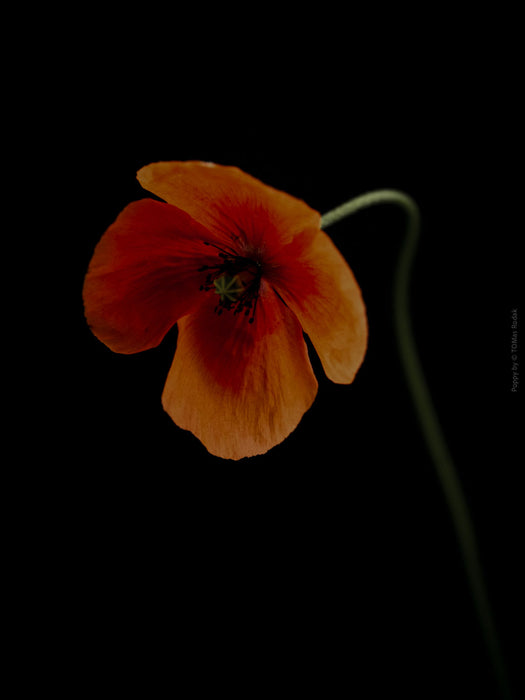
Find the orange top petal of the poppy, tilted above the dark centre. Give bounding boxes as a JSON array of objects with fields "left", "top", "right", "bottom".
[{"left": 137, "top": 161, "right": 321, "bottom": 256}]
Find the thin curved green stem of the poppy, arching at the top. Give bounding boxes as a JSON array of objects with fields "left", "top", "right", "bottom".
[{"left": 321, "top": 190, "right": 511, "bottom": 698}]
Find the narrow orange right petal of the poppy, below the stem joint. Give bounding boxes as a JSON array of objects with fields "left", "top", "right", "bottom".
[{"left": 270, "top": 231, "right": 368, "bottom": 384}]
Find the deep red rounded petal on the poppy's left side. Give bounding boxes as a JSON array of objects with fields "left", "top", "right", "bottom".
[{"left": 83, "top": 199, "right": 221, "bottom": 353}]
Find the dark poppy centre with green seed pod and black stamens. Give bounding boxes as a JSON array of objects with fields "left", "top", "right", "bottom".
[{"left": 199, "top": 241, "right": 262, "bottom": 323}]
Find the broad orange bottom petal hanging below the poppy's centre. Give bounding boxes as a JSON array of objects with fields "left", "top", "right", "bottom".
[{"left": 162, "top": 281, "right": 317, "bottom": 459}]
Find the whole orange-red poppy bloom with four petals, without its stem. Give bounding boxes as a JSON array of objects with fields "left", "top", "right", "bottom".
[{"left": 83, "top": 162, "right": 367, "bottom": 459}]
